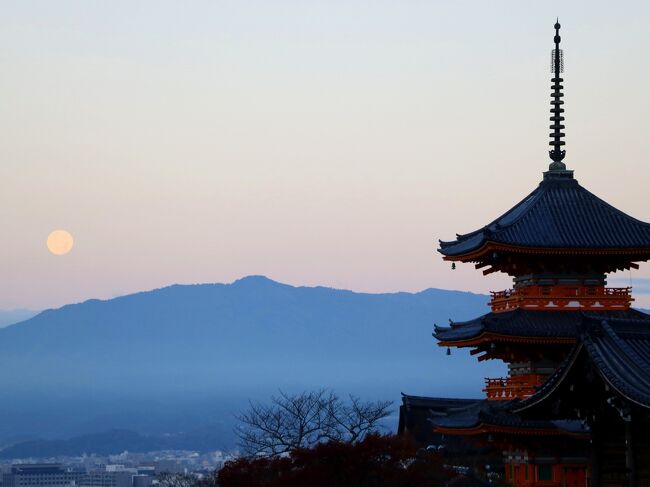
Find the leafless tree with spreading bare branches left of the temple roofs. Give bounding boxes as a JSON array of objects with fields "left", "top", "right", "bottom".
[{"left": 235, "top": 389, "right": 392, "bottom": 456}]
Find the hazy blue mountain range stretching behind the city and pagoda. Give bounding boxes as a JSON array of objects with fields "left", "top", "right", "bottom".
[{"left": 0, "top": 276, "right": 502, "bottom": 454}]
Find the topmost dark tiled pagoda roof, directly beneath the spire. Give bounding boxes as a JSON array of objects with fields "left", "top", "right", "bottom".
[{"left": 439, "top": 171, "right": 650, "bottom": 260}]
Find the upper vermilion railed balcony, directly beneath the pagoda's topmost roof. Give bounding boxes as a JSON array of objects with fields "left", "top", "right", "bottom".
[{"left": 490, "top": 285, "right": 634, "bottom": 313}]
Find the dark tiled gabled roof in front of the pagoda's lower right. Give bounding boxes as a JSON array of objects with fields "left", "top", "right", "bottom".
[{"left": 514, "top": 317, "right": 650, "bottom": 411}]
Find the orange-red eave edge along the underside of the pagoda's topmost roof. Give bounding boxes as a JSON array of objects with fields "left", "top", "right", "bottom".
[{"left": 438, "top": 240, "right": 650, "bottom": 262}]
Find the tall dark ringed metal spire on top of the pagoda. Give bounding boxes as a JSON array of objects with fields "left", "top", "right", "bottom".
[{"left": 548, "top": 19, "right": 566, "bottom": 171}]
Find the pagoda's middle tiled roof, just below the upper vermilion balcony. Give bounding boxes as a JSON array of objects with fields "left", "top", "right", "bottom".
[{"left": 433, "top": 308, "right": 650, "bottom": 347}]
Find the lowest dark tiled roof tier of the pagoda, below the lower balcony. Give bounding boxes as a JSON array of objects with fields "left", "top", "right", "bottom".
[{"left": 402, "top": 396, "right": 587, "bottom": 437}]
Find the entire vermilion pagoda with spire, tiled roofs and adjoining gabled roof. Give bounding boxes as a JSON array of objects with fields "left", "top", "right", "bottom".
[{"left": 399, "top": 23, "right": 650, "bottom": 487}]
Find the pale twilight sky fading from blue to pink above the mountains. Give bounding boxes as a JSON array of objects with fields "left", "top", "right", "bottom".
[{"left": 0, "top": 0, "right": 650, "bottom": 309}]
